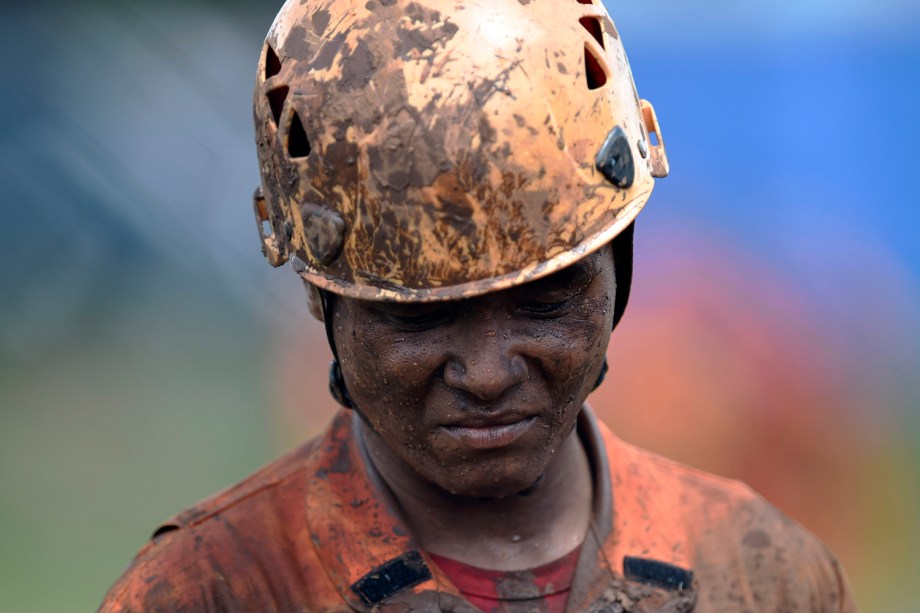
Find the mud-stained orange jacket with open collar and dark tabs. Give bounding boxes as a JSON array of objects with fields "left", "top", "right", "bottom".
[{"left": 100, "top": 409, "right": 856, "bottom": 613}]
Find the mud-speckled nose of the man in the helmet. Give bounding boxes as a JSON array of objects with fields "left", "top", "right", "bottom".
[{"left": 444, "top": 322, "right": 527, "bottom": 401}]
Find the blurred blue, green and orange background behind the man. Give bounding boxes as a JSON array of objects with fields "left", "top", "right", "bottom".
[{"left": 0, "top": 0, "right": 920, "bottom": 612}]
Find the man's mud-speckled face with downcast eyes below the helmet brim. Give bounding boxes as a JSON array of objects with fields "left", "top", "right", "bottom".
[{"left": 333, "top": 246, "right": 616, "bottom": 497}]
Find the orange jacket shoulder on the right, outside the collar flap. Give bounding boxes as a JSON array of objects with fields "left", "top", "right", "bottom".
[{"left": 608, "top": 436, "right": 856, "bottom": 612}]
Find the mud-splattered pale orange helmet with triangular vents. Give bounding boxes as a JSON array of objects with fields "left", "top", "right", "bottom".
[{"left": 254, "top": 0, "right": 668, "bottom": 301}]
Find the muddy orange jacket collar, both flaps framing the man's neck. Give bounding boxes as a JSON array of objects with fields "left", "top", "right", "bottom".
[{"left": 306, "top": 406, "right": 689, "bottom": 613}]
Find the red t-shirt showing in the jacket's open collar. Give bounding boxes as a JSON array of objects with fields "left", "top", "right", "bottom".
[{"left": 429, "top": 547, "right": 581, "bottom": 613}]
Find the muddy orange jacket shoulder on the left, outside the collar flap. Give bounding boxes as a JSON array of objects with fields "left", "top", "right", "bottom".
[{"left": 99, "top": 439, "right": 330, "bottom": 612}]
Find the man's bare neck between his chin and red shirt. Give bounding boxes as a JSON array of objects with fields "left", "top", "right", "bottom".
[{"left": 362, "top": 420, "right": 592, "bottom": 570}]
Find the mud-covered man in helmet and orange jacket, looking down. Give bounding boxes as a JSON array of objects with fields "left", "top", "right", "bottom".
[{"left": 102, "top": 0, "right": 854, "bottom": 612}]
